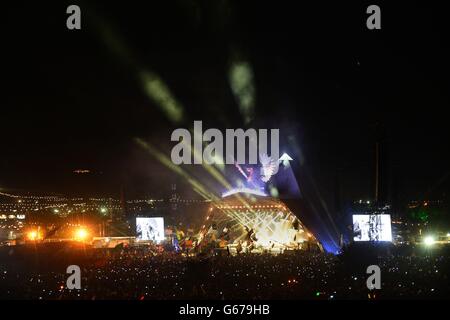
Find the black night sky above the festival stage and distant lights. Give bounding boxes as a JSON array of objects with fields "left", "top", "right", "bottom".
[{"left": 0, "top": 0, "right": 450, "bottom": 205}]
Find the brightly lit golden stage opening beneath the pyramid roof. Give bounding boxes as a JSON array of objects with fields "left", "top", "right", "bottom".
[{"left": 200, "top": 190, "right": 322, "bottom": 253}]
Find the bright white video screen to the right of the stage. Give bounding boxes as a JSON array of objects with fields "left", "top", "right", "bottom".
[{"left": 353, "top": 214, "right": 392, "bottom": 241}]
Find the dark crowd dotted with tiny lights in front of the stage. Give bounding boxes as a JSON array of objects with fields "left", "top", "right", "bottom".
[{"left": 0, "top": 242, "right": 450, "bottom": 300}]
